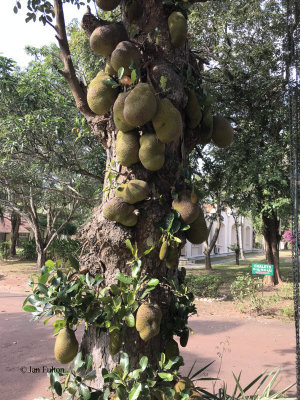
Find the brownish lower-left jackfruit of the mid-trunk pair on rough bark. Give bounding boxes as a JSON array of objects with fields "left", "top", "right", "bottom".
[{"left": 103, "top": 197, "right": 138, "bottom": 226}]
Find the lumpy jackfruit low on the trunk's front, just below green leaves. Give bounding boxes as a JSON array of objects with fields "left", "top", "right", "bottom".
[{"left": 136, "top": 304, "right": 162, "bottom": 342}]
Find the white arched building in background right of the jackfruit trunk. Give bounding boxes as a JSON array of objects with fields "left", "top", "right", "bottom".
[{"left": 181, "top": 205, "right": 255, "bottom": 258}]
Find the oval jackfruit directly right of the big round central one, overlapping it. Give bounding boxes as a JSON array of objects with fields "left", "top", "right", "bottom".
[{"left": 152, "top": 99, "right": 182, "bottom": 143}]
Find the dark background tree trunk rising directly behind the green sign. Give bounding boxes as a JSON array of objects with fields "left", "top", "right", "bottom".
[{"left": 262, "top": 215, "right": 282, "bottom": 286}]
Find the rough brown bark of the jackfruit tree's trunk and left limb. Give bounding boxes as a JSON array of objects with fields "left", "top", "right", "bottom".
[{"left": 54, "top": 0, "right": 206, "bottom": 388}]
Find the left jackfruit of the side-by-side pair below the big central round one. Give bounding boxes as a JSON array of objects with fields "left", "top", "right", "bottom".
[{"left": 116, "top": 131, "right": 140, "bottom": 167}]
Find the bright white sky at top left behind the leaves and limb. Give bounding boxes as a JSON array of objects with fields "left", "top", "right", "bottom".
[{"left": 0, "top": 0, "right": 86, "bottom": 67}]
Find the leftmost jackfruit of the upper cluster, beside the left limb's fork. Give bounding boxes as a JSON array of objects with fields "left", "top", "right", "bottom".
[{"left": 87, "top": 71, "right": 118, "bottom": 115}]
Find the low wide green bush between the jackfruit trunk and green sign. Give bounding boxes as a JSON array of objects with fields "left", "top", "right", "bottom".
[{"left": 185, "top": 274, "right": 223, "bottom": 297}]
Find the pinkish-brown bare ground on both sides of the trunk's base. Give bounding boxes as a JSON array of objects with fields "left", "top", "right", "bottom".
[{"left": 0, "top": 262, "right": 296, "bottom": 400}]
